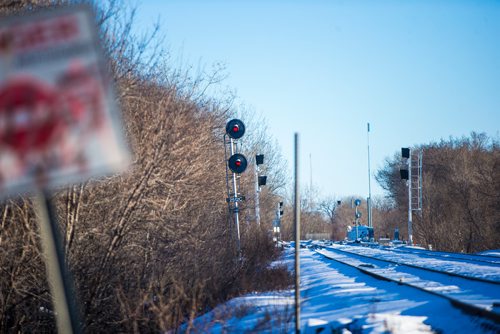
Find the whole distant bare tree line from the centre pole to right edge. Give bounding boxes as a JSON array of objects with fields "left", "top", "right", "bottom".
[{"left": 284, "top": 132, "right": 500, "bottom": 253}]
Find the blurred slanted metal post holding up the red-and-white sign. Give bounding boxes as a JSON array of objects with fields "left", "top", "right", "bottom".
[{"left": 35, "top": 191, "right": 82, "bottom": 334}]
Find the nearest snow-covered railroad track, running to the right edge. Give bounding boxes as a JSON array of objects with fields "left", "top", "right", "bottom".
[{"left": 315, "top": 247, "right": 500, "bottom": 325}]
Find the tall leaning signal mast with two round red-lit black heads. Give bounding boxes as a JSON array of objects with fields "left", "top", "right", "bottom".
[{"left": 224, "top": 119, "right": 248, "bottom": 253}]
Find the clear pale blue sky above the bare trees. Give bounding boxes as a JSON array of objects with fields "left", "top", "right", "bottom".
[{"left": 133, "top": 0, "right": 500, "bottom": 196}]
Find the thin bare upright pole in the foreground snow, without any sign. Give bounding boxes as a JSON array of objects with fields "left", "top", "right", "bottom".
[{"left": 294, "top": 133, "right": 300, "bottom": 333}]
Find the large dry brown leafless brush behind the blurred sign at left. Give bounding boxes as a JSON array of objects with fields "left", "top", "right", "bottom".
[{"left": 0, "top": 1, "right": 288, "bottom": 333}]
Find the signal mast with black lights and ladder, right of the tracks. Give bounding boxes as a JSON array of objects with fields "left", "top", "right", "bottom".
[{"left": 399, "top": 147, "right": 423, "bottom": 245}]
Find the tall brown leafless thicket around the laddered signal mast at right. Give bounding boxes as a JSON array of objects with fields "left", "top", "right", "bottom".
[{"left": 377, "top": 132, "right": 500, "bottom": 253}]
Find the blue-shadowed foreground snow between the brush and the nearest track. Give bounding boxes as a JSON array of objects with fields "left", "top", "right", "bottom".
[{"left": 183, "top": 248, "right": 493, "bottom": 334}]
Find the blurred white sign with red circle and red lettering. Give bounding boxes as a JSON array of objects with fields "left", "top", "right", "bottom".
[{"left": 0, "top": 6, "right": 129, "bottom": 197}]
